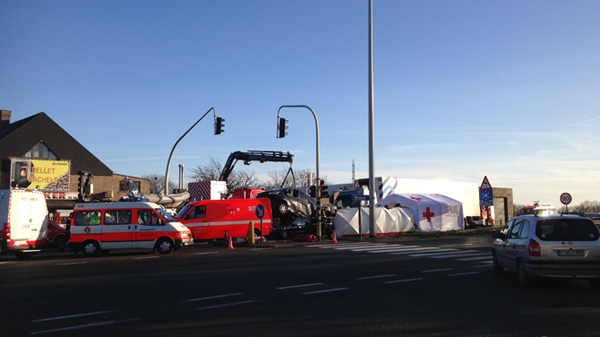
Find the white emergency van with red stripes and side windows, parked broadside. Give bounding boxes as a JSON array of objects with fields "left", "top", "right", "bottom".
[{"left": 69, "top": 201, "right": 194, "bottom": 255}]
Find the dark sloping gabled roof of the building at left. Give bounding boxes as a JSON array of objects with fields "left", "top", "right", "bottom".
[{"left": 0, "top": 112, "right": 113, "bottom": 176}]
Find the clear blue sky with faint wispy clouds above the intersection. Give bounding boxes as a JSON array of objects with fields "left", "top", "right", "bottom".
[{"left": 0, "top": 0, "right": 600, "bottom": 206}]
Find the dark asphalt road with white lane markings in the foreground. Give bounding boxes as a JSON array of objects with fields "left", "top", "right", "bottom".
[{"left": 0, "top": 236, "right": 600, "bottom": 336}]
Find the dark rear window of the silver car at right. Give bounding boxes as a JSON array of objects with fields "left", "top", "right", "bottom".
[{"left": 535, "top": 219, "right": 600, "bottom": 241}]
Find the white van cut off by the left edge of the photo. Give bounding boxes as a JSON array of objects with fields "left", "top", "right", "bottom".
[{"left": 0, "top": 190, "right": 48, "bottom": 259}]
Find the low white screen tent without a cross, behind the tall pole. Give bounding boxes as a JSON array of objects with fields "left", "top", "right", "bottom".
[{"left": 333, "top": 207, "right": 414, "bottom": 237}]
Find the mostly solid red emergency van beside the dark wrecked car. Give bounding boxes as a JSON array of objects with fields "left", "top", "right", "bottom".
[{"left": 175, "top": 199, "right": 273, "bottom": 240}]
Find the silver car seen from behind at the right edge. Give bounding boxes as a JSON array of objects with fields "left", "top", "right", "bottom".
[{"left": 492, "top": 215, "right": 600, "bottom": 288}]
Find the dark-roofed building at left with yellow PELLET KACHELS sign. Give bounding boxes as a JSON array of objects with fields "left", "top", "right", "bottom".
[{"left": 0, "top": 110, "right": 150, "bottom": 211}]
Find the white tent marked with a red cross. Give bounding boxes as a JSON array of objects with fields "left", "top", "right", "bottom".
[{"left": 377, "top": 194, "right": 465, "bottom": 232}]
